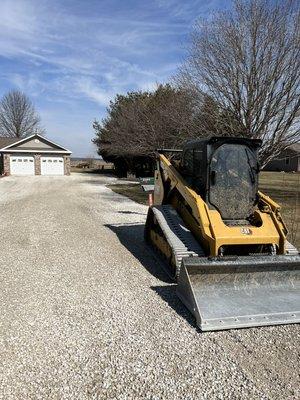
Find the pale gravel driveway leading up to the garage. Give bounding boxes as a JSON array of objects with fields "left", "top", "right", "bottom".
[{"left": 0, "top": 174, "right": 300, "bottom": 400}]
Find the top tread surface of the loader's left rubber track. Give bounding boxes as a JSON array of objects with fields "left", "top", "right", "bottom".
[{"left": 152, "top": 205, "right": 205, "bottom": 271}]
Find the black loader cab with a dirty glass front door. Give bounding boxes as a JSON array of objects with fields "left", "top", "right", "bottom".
[{"left": 181, "top": 137, "right": 261, "bottom": 225}]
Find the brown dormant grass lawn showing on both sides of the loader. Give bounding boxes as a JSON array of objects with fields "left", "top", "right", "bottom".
[{"left": 108, "top": 172, "right": 300, "bottom": 248}]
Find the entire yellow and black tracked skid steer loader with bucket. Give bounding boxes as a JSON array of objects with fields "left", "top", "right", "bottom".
[{"left": 145, "top": 137, "right": 300, "bottom": 331}]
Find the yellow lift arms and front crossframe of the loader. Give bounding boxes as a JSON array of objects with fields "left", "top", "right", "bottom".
[{"left": 154, "top": 154, "right": 287, "bottom": 256}]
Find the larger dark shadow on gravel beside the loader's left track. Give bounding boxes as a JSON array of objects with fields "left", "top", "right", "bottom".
[{"left": 104, "top": 223, "right": 171, "bottom": 282}]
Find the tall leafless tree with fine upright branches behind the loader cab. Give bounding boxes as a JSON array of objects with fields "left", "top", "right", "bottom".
[{"left": 179, "top": 0, "right": 300, "bottom": 165}]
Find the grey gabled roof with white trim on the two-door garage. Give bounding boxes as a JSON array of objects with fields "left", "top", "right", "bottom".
[{"left": 0, "top": 133, "right": 72, "bottom": 154}]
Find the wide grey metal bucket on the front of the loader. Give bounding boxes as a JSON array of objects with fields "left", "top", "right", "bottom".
[{"left": 177, "top": 255, "right": 300, "bottom": 331}]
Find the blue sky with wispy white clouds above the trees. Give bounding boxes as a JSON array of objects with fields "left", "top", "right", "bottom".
[{"left": 0, "top": 0, "right": 230, "bottom": 156}]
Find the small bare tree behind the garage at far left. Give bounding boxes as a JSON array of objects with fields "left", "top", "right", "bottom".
[{"left": 0, "top": 90, "right": 44, "bottom": 138}]
